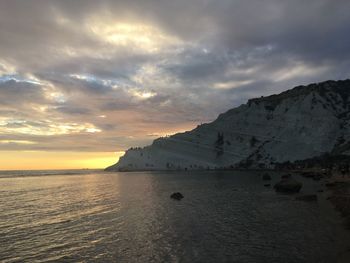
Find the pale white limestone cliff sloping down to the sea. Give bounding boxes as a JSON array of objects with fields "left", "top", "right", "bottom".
[{"left": 107, "top": 80, "right": 350, "bottom": 171}]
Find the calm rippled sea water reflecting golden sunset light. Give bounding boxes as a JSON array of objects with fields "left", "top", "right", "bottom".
[{"left": 0, "top": 171, "right": 347, "bottom": 262}]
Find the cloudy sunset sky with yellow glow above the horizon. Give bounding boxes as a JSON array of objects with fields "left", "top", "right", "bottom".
[{"left": 0, "top": 0, "right": 350, "bottom": 170}]
